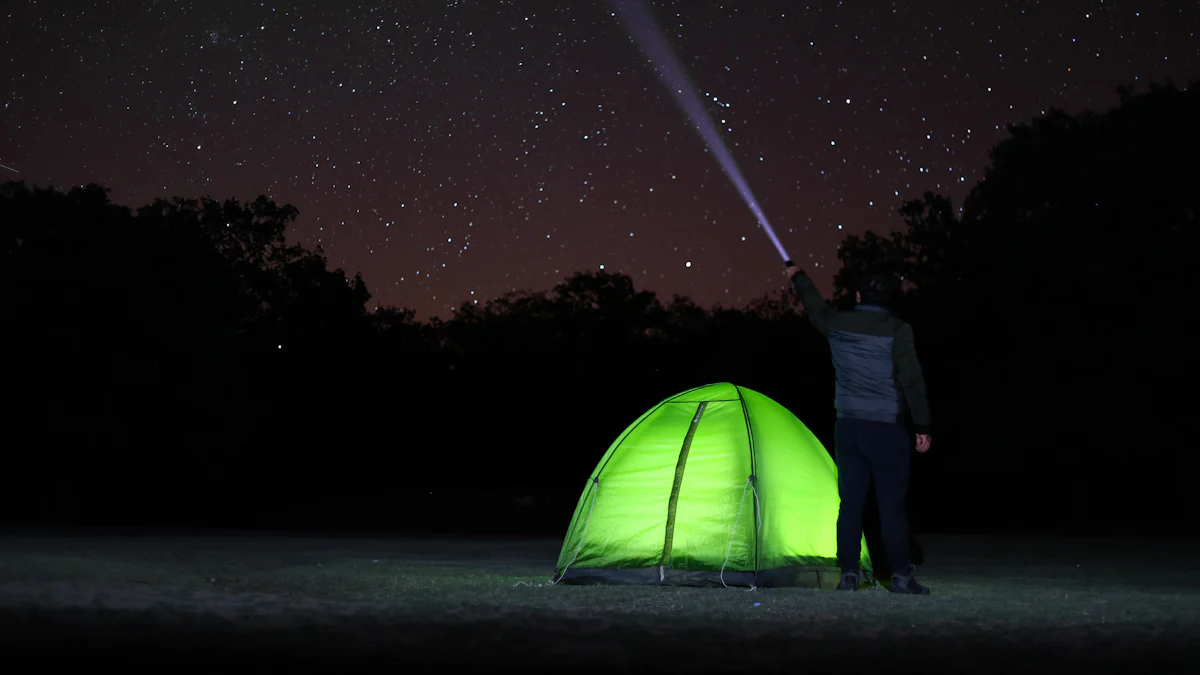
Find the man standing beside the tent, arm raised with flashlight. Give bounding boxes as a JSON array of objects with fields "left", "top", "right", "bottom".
[{"left": 786, "top": 265, "right": 930, "bottom": 595}]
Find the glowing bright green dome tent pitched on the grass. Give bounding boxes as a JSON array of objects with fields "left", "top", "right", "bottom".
[{"left": 554, "top": 382, "right": 871, "bottom": 587}]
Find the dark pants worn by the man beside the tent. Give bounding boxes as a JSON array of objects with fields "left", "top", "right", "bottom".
[{"left": 834, "top": 418, "right": 912, "bottom": 574}]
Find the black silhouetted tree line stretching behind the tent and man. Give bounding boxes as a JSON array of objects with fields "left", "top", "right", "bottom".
[{"left": 0, "top": 83, "right": 1200, "bottom": 532}]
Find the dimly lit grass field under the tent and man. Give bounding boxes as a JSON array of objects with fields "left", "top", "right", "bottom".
[{"left": 0, "top": 534, "right": 1200, "bottom": 673}]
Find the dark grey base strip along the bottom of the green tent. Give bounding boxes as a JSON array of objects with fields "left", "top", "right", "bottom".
[{"left": 554, "top": 566, "right": 869, "bottom": 589}]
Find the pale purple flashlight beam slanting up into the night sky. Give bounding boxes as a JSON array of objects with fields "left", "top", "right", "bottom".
[{"left": 612, "top": 0, "right": 791, "bottom": 261}]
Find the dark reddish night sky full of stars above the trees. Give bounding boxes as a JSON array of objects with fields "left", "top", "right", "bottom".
[{"left": 0, "top": 0, "right": 1200, "bottom": 318}]
